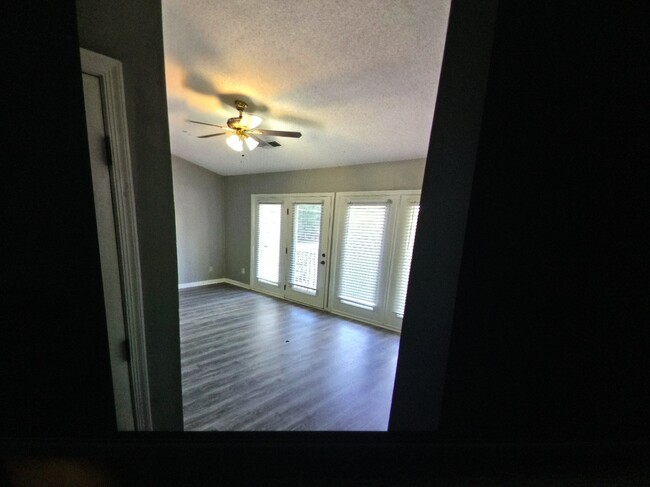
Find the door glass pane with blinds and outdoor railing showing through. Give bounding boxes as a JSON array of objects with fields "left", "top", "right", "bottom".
[{"left": 289, "top": 203, "right": 323, "bottom": 296}]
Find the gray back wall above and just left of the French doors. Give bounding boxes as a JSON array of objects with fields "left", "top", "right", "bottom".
[{"left": 225, "top": 159, "right": 425, "bottom": 284}]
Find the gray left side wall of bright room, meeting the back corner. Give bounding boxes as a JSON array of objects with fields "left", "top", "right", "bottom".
[{"left": 172, "top": 155, "right": 226, "bottom": 284}]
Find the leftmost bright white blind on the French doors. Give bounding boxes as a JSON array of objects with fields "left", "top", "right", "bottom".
[{"left": 255, "top": 203, "right": 282, "bottom": 285}]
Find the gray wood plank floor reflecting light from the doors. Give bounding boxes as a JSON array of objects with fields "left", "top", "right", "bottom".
[{"left": 179, "top": 284, "right": 399, "bottom": 431}]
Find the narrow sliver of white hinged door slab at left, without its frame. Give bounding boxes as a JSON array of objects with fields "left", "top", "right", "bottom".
[{"left": 83, "top": 73, "right": 135, "bottom": 431}]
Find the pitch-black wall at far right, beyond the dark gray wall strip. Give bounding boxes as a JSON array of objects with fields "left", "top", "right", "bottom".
[{"left": 428, "top": 1, "right": 650, "bottom": 441}]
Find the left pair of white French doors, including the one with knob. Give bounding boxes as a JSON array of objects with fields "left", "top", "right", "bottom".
[{"left": 251, "top": 194, "right": 332, "bottom": 309}]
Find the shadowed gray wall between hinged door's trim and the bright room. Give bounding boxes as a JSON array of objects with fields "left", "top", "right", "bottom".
[{"left": 77, "top": 0, "right": 183, "bottom": 430}]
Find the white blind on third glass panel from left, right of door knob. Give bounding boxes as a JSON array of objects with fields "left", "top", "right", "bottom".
[{"left": 338, "top": 202, "right": 389, "bottom": 310}]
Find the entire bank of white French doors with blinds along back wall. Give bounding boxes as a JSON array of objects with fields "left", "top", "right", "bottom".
[{"left": 251, "top": 191, "right": 420, "bottom": 331}]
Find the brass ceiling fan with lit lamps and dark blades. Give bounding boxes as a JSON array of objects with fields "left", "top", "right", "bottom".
[{"left": 188, "top": 100, "right": 302, "bottom": 152}]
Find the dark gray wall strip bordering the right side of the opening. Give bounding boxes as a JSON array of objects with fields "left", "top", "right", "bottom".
[{"left": 389, "top": 1, "right": 497, "bottom": 431}]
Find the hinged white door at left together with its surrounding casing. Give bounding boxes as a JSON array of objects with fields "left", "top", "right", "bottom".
[{"left": 80, "top": 49, "right": 153, "bottom": 431}]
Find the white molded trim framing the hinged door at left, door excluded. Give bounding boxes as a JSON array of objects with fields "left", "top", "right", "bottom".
[{"left": 80, "top": 48, "right": 153, "bottom": 431}]
